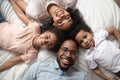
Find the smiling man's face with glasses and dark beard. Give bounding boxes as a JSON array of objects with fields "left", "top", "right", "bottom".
[{"left": 57, "top": 40, "right": 77, "bottom": 70}]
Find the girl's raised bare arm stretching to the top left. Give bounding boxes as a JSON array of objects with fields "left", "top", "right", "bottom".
[{"left": 9, "top": 0, "right": 30, "bottom": 25}]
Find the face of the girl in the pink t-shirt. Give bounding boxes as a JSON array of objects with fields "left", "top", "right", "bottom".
[{"left": 37, "top": 31, "right": 57, "bottom": 49}]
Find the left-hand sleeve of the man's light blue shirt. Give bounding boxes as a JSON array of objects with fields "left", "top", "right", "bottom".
[{"left": 22, "top": 62, "right": 39, "bottom": 80}]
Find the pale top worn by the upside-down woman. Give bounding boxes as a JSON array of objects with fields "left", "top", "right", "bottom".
[{"left": 26, "top": 0, "right": 77, "bottom": 22}]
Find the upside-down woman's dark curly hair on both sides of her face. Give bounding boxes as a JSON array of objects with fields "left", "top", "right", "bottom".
[{"left": 42, "top": 8, "right": 81, "bottom": 33}]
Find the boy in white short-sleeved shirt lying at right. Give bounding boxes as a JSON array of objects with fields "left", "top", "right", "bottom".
[{"left": 71, "top": 24, "right": 120, "bottom": 80}]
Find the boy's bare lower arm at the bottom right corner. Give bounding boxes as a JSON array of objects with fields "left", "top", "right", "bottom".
[{"left": 92, "top": 67, "right": 117, "bottom": 80}]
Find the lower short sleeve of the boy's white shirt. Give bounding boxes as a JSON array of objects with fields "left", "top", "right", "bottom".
[{"left": 87, "top": 54, "right": 97, "bottom": 69}]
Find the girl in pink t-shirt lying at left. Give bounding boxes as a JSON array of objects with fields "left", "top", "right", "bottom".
[{"left": 0, "top": 14, "right": 65, "bottom": 72}]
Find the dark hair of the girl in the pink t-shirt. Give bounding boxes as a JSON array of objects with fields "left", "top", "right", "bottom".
[{"left": 47, "top": 27, "right": 66, "bottom": 52}]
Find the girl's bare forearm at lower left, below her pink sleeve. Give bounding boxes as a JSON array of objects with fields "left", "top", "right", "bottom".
[{"left": 0, "top": 56, "right": 23, "bottom": 72}]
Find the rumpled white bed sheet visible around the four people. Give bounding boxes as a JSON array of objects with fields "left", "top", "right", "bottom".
[{"left": 0, "top": 0, "right": 120, "bottom": 80}]
